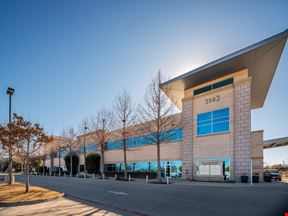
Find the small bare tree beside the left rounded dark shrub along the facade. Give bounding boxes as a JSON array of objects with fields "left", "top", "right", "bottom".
[{"left": 62, "top": 127, "right": 79, "bottom": 177}]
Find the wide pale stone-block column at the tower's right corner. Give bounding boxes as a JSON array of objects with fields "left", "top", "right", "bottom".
[{"left": 234, "top": 78, "right": 251, "bottom": 182}]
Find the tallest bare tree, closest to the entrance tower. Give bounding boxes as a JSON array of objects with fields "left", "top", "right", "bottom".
[{"left": 138, "top": 71, "right": 175, "bottom": 182}]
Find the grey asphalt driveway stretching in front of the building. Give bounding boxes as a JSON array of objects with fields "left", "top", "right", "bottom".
[{"left": 0, "top": 176, "right": 288, "bottom": 216}]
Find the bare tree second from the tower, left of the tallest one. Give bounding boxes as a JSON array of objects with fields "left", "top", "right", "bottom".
[{"left": 114, "top": 89, "right": 136, "bottom": 178}]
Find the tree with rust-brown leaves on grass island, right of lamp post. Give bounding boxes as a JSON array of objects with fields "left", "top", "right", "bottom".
[{"left": 13, "top": 113, "right": 53, "bottom": 192}]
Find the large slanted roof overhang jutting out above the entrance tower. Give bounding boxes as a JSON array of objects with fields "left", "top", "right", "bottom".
[{"left": 160, "top": 29, "right": 288, "bottom": 110}]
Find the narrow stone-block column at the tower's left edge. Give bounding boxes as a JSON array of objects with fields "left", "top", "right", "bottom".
[{"left": 182, "top": 96, "right": 193, "bottom": 179}]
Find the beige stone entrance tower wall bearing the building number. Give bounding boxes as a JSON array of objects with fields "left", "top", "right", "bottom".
[{"left": 182, "top": 69, "right": 263, "bottom": 182}]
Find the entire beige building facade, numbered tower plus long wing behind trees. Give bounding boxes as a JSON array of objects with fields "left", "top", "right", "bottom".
[{"left": 47, "top": 69, "right": 263, "bottom": 182}]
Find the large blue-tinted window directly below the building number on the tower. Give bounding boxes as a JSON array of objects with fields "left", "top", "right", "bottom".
[{"left": 197, "top": 108, "right": 230, "bottom": 135}]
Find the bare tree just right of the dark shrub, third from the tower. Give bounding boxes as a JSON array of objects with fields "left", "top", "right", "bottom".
[{"left": 88, "top": 108, "right": 114, "bottom": 175}]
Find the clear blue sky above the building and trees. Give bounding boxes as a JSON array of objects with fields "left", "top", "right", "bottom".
[{"left": 0, "top": 0, "right": 288, "bottom": 164}]
